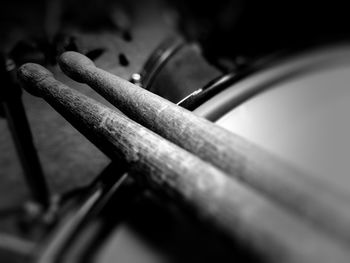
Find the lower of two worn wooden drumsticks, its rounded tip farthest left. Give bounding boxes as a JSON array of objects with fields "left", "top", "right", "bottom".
[{"left": 19, "top": 64, "right": 350, "bottom": 263}]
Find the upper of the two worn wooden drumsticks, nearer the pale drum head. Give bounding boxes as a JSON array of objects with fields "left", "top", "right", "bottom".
[{"left": 60, "top": 52, "right": 350, "bottom": 242}]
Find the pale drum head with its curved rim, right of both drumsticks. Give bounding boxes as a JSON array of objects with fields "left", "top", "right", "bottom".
[{"left": 194, "top": 46, "right": 350, "bottom": 193}]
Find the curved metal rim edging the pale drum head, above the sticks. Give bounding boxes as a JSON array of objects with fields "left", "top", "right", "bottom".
[{"left": 191, "top": 43, "right": 350, "bottom": 122}]
